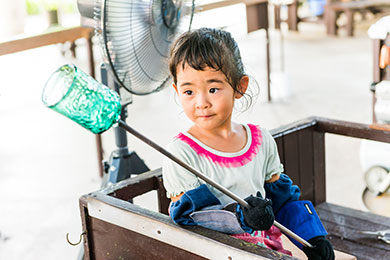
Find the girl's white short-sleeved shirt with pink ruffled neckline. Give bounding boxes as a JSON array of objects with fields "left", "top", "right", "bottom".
[{"left": 163, "top": 124, "right": 283, "bottom": 205}]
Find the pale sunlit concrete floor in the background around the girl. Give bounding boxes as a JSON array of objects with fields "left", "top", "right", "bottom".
[{"left": 0, "top": 7, "right": 386, "bottom": 260}]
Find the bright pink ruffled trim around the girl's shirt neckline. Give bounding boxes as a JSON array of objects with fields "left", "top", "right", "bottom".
[{"left": 176, "top": 124, "right": 263, "bottom": 168}]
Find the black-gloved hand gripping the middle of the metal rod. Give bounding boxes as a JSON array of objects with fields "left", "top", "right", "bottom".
[{"left": 242, "top": 192, "right": 275, "bottom": 230}]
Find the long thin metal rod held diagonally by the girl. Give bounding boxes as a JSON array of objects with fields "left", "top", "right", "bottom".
[{"left": 118, "top": 120, "right": 313, "bottom": 247}]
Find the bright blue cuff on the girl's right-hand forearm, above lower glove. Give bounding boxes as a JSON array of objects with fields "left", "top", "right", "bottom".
[{"left": 276, "top": 200, "right": 328, "bottom": 249}]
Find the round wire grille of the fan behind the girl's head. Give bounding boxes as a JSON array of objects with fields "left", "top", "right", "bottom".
[{"left": 94, "top": 0, "right": 194, "bottom": 95}]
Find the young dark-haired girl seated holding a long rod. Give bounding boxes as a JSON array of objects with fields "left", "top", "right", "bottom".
[{"left": 163, "top": 28, "right": 334, "bottom": 260}]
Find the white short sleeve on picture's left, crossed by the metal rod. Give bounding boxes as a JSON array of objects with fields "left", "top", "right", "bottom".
[{"left": 162, "top": 139, "right": 201, "bottom": 198}]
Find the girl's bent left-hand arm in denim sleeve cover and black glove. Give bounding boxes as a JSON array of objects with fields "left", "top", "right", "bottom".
[{"left": 169, "top": 184, "right": 275, "bottom": 234}]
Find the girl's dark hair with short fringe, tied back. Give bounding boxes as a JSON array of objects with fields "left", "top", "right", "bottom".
[{"left": 169, "top": 28, "right": 246, "bottom": 97}]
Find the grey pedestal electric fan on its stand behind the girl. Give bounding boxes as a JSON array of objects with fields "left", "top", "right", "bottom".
[{"left": 77, "top": 0, "right": 195, "bottom": 183}]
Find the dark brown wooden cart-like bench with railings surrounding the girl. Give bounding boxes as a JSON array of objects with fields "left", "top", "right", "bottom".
[{"left": 80, "top": 117, "right": 390, "bottom": 260}]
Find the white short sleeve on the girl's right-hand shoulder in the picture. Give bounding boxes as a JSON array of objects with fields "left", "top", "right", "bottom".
[{"left": 261, "top": 129, "right": 283, "bottom": 181}]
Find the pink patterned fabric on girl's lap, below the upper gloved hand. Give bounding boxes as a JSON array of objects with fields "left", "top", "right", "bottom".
[{"left": 232, "top": 226, "right": 292, "bottom": 256}]
